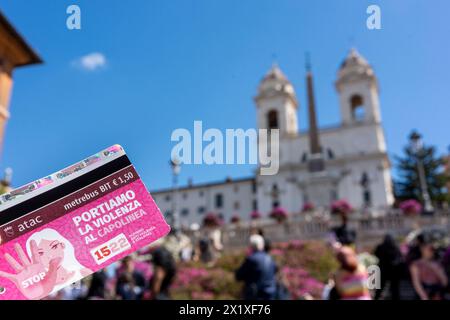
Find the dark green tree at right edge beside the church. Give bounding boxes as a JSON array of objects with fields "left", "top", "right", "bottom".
[{"left": 394, "top": 132, "right": 449, "bottom": 203}]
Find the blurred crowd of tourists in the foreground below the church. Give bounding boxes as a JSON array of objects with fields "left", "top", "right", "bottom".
[{"left": 44, "top": 212, "right": 450, "bottom": 300}]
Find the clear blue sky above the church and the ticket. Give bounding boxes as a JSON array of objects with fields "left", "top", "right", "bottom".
[{"left": 0, "top": 0, "right": 450, "bottom": 189}]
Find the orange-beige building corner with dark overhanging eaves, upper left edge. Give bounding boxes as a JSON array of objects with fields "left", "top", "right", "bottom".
[{"left": 0, "top": 12, "right": 42, "bottom": 157}]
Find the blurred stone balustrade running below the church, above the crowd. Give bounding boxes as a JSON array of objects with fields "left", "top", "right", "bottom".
[{"left": 187, "top": 211, "right": 450, "bottom": 249}]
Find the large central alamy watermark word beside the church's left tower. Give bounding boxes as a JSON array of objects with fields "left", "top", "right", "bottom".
[{"left": 171, "top": 121, "right": 280, "bottom": 175}]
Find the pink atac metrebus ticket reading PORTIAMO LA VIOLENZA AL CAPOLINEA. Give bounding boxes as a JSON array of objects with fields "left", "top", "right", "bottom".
[{"left": 0, "top": 145, "right": 170, "bottom": 299}]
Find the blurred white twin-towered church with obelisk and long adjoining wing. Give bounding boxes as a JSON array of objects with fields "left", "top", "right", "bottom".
[{"left": 151, "top": 49, "right": 394, "bottom": 226}]
